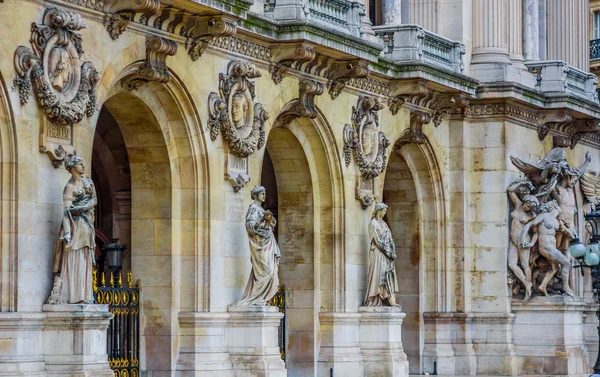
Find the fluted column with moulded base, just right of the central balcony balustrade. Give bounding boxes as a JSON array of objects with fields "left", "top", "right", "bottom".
[{"left": 472, "top": 0, "right": 510, "bottom": 64}]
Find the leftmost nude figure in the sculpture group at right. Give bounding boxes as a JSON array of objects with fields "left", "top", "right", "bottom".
[{"left": 508, "top": 180, "right": 540, "bottom": 300}]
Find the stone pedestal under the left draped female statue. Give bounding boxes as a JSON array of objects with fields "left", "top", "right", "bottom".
[{"left": 42, "top": 304, "right": 114, "bottom": 377}]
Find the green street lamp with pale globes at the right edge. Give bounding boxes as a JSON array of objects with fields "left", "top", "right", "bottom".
[{"left": 569, "top": 205, "right": 600, "bottom": 377}]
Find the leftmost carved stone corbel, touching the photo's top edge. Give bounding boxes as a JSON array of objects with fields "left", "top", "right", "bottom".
[{"left": 106, "top": 0, "right": 160, "bottom": 40}]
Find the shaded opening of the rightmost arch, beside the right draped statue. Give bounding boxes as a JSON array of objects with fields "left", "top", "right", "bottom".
[{"left": 383, "top": 149, "right": 423, "bottom": 374}]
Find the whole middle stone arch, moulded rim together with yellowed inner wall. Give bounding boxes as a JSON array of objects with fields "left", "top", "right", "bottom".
[{"left": 265, "top": 106, "right": 343, "bottom": 376}]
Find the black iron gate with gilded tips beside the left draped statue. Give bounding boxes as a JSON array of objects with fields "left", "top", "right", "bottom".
[{"left": 94, "top": 271, "right": 140, "bottom": 377}]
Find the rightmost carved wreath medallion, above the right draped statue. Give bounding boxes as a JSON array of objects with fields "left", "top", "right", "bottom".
[{"left": 344, "top": 97, "right": 390, "bottom": 179}]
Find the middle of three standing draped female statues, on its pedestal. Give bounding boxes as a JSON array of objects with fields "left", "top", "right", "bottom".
[{"left": 235, "top": 186, "right": 281, "bottom": 306}]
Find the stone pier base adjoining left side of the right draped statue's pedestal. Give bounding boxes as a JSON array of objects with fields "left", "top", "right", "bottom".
[{"left": 318, "top": 312, "right": 365, "bottom": 377}]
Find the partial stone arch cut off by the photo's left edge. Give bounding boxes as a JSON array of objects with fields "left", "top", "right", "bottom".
[{"left": 0, "top": 72, "right": 18, "bottom": 312}]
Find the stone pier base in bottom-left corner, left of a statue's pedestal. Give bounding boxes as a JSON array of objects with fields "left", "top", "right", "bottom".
[{"left": 0, "top": 313, "right": 46, "bottom": 377}]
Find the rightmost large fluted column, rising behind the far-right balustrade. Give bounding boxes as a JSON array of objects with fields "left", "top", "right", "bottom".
[{"left": 546, "top": 0, "right": 590, "bottom": 71}]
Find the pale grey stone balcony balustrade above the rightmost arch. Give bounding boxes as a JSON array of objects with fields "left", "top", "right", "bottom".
[{"left": 373, "top": 24, "right": 465, "bottom": 73}]
